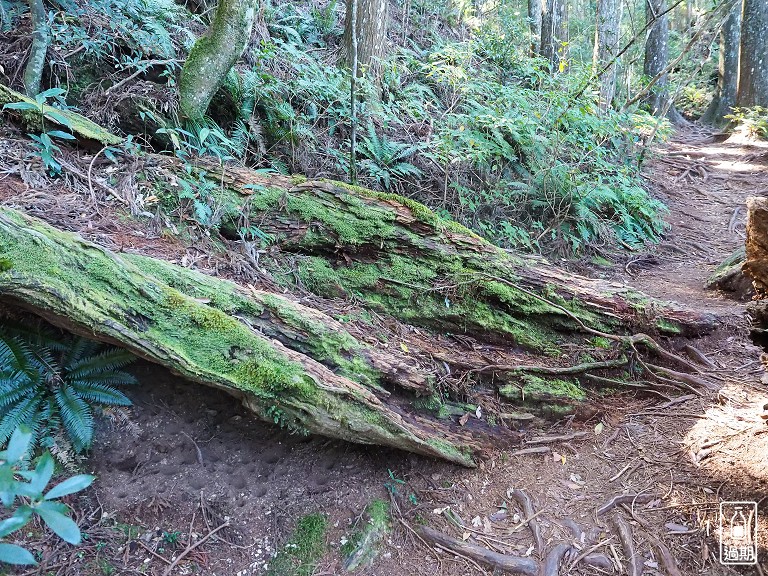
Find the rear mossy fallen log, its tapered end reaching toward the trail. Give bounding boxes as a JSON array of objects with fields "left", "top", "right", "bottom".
[{"left": 192, "top": 165, "right": 717, "bottom": 356}]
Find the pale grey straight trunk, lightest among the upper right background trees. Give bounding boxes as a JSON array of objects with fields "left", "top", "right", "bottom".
[{"left": 592, "top": 0, "right": 622, "bottom": 111}]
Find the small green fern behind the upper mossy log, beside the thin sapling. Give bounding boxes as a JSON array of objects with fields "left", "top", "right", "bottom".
[{"left": 358, "top": 124, "right": 424, "bottom": 190}]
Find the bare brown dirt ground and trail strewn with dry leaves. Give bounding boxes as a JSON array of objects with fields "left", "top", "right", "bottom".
[{"left": 0, "top": 131, "right": 768, "bottom": 576}]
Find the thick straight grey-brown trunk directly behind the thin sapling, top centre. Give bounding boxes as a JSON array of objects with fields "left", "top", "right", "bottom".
[{"left": 344, "top": 0, "right": 388, "bottom": 81}]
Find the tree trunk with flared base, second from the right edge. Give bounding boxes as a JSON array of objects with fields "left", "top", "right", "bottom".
[{"left": 701, "top": 3, "right": 741, "bottom": 126}]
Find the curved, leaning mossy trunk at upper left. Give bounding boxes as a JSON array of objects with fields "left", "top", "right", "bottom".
[{"left": 179, "top": 0, "right": 256, "bottom": 120}]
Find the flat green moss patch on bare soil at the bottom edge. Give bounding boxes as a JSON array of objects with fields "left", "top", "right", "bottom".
[{"left": 267, "top": 514, "right": 328, "bottom": 576}]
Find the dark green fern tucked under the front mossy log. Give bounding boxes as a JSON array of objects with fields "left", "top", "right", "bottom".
[{"left": 0, "top": 327, "right": 136, "bottom": 454}]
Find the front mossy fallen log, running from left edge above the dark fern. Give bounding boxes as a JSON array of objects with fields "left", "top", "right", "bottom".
[{"left": 0, "top": 208, "right": 474, "bottom": 465}]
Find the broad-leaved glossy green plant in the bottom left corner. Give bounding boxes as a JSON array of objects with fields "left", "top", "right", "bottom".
[{"left": 0, "top": 425, "right": 94, "bottom": 565}]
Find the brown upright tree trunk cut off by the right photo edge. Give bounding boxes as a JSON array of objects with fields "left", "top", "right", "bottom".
[{"left": 736, "top": 0, "right": 768, "bottom": 107}]
